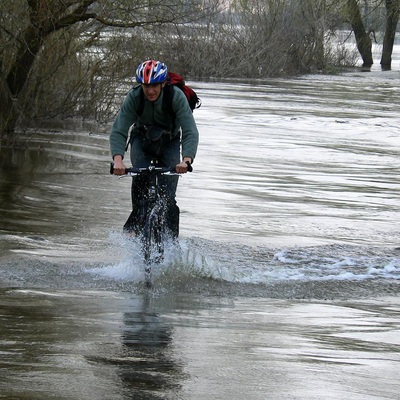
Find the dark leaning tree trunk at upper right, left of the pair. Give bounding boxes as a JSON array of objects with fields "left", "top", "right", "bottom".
[{"left": 347, "top": 0, "right": 374, "bottom": 69}]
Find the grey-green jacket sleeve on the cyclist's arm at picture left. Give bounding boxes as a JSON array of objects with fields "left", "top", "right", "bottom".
[{"left": 110, "top": 89, "right": 138, "bottom": 158}]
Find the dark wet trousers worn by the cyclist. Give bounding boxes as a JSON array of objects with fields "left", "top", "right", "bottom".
[{"left": 124, "top": 133, "right": 180, "bottom": 238}]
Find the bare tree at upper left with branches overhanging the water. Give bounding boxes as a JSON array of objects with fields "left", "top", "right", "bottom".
[{"left": 0, "top": 0, "right": 212, "bottom": 137}]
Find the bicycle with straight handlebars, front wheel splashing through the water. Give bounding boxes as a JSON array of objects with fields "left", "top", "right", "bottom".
[{"left": 110, "top": 158, "right": 193, "bottom": 286}]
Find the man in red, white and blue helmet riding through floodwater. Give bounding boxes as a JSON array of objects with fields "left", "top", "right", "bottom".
[{"left": 110, "top": 60, "right": 199, "bottom": 238}]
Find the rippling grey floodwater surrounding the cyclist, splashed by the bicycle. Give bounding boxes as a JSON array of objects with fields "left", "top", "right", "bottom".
[{"left": 0, "top": 65, "right": 400, "bottom": 400}]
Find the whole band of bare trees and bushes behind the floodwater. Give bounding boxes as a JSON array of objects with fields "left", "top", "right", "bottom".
[{"left": 0, "top": 0, "right": 400, "bottom": 140}]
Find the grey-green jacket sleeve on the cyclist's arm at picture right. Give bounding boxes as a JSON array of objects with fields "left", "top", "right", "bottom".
[{"left": 172, "top": 87, "right": 199, "bottom": 160}]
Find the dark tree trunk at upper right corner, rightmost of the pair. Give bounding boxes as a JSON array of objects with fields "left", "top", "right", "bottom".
[{"left": 381, "top": 0, "right": 400, "bottom": 70}]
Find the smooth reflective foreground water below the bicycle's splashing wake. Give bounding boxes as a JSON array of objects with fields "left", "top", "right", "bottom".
[{"left": 0, "top": 289, "right": 400, "bottom": 400}]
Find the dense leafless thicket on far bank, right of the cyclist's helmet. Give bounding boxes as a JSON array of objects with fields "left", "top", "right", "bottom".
[{"left": 178, "top": 0, "right": 350, "bottom": 78}]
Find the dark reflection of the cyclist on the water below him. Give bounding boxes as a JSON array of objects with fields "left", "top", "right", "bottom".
[{"left": 86, "top": 295, "right": 184, "bottom": 399}]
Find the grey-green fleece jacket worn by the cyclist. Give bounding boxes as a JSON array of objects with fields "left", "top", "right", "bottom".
[{"left": 110, "top": 86, "right": 199, "bottom": 160}]
